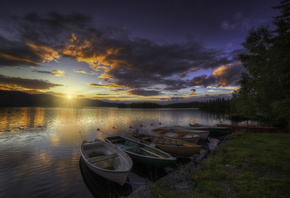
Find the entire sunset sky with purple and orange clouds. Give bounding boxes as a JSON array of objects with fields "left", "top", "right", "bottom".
[{"left": 0, "top": 0, "right": 279, "bottom": 103}]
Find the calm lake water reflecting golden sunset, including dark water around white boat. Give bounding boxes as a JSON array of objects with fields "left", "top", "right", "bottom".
[{"left": 0, "top": 108, "right": 230, "bottom": 198}]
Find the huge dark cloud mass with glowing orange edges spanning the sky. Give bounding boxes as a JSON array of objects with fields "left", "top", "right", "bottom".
[{"left": 0, "top": 12, "right": 245, "bottom": 96}]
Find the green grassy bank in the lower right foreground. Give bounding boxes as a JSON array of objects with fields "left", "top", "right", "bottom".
[{"left": 149, "top": 132, "right": 290, "bottom": 198}]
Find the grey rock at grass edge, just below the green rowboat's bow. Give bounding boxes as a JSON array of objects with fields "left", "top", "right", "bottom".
[{"left": 156, "top": 171, "right": 195, "bottom": 189}]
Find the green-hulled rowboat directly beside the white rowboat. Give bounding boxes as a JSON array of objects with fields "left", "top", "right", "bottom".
[{"left": 105, "top": 136, "right": 176, "bottom": 167}]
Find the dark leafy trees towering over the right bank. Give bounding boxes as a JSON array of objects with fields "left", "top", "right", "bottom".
[{"left": 232, "top": 0, "right": 290, "bottom": 124}]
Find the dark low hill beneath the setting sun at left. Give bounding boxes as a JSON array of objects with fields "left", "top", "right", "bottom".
[{"left": 0, "top": 91, "right": 117, "bottom": 107}]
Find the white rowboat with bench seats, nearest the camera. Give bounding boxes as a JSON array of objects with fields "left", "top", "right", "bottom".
[{"left": 80, "top": 139, "right": 133, "bottom": 185}]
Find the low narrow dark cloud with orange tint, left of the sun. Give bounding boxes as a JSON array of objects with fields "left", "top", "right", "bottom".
[{"left": 0, "top": 75, "right": 63, "bottom": 90}]
